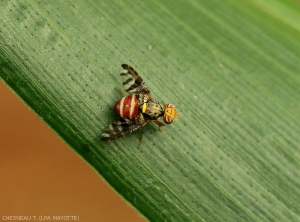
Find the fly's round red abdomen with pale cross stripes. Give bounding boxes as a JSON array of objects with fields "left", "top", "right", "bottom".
[{"left": 115, "top": 96, "right": 140, "bottom": 119}]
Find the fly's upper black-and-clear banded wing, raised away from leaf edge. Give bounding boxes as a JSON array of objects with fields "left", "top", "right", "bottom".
[{"left": 121, "top": 64, "right": 152, "bottom": 100}]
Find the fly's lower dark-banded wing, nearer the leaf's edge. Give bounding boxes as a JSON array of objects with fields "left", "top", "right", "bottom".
[{"left": 101, "top": 118, "right": 148, "bottom": 140}]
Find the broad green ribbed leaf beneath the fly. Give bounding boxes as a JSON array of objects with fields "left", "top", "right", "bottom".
[{"left": 0, "top": 0, "right": 300, "bottom": 221}]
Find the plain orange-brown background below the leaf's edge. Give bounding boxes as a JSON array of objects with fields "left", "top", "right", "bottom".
[{"left": 0, "top": 80, "right": 145, "bottom": 222}]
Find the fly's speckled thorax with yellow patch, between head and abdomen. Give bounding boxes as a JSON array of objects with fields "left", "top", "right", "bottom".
[{"left": 139, "top": 100, "right": 164, "bottom": 120}]
